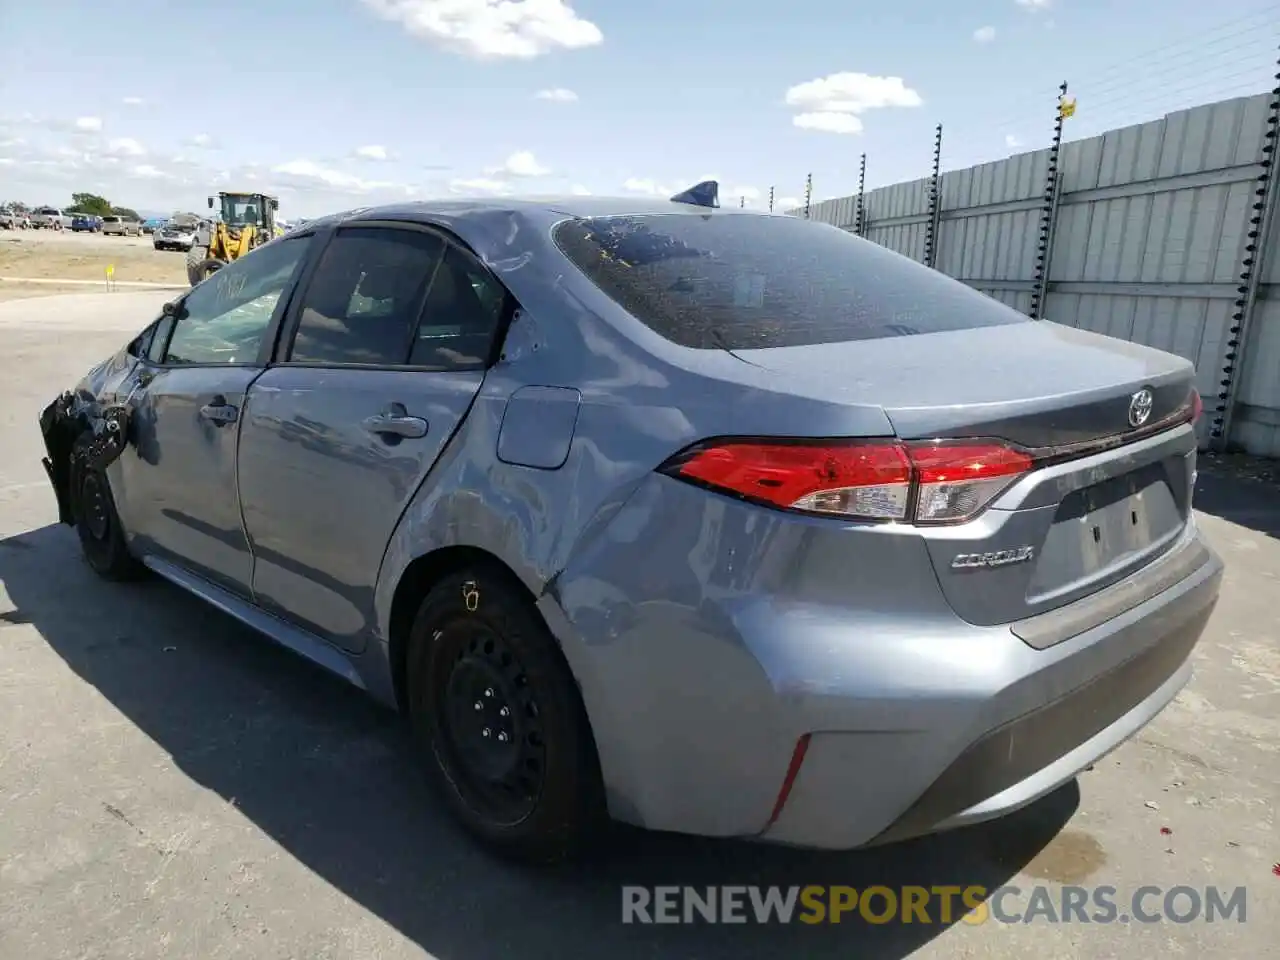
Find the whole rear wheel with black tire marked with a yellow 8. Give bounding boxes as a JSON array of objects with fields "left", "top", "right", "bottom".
[{"left": 407, "top": 566, "right": 607, "bottom": 864}]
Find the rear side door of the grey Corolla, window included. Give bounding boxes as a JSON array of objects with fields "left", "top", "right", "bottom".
[{"left": 239, "top": 224, "right": 509, "bottom": 652}]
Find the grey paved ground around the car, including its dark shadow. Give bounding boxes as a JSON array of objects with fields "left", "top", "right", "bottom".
[{"left": 0, "top": 293, "right": 1280, "bottom": 960}]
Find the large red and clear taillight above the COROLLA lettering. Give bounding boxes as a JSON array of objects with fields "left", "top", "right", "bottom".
[{"left": 662, "top": 439, "right": 1034, "bottom": 524}]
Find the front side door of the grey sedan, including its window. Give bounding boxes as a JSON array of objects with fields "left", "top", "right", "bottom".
[{"left": 119, "top": 237, "right": 311, "bottom": 596}]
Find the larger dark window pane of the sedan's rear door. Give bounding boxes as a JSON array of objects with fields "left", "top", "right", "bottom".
[{"left": 289, "top": 227, "right": 445, "bottom": 366}]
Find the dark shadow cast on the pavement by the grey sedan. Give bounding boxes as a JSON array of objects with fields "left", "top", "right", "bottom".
[{"left": 0, "top": 526, "right": 1079, "bottom": 960}]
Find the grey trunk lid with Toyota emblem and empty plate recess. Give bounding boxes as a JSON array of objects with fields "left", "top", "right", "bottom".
[{"left": 735, "top": 321, "right": 1196, "bottom": 625}]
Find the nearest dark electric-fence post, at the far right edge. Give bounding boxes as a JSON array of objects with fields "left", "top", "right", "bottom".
[{"left": 1210, "top": 45, "right": 1280, "bottom": 451}]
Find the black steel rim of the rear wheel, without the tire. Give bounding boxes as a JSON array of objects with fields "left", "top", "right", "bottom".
[{"left": 434, "top": 620, "right": 547, "bottom": 824}]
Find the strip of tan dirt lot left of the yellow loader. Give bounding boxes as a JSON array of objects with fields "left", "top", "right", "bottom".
[{"left": 0, "top": 230, "right": 187, "bottom": 288}]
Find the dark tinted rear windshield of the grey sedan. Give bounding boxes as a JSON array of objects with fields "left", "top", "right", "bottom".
[{"left": 554, "top": 214, "right": 1028, "bottom": 349}]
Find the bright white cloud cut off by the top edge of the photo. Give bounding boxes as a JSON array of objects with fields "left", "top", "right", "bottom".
[{"left": 362, "top": 0, "right": 604, "bottom": 60}]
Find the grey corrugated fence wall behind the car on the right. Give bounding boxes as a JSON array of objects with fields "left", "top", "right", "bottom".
[{"left": 810, "top": 93, "right": 1280, "bottom": 456}]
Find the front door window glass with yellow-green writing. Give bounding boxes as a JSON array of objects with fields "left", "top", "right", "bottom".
[{"left": 165, "top": 237, "right": 311, "bottom": 365}]
